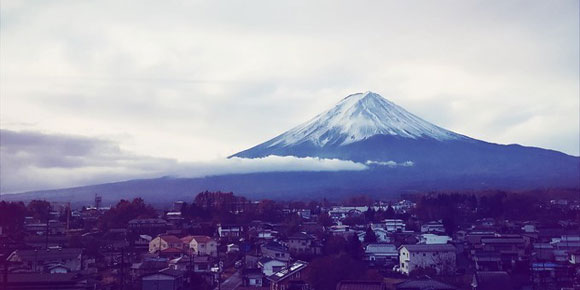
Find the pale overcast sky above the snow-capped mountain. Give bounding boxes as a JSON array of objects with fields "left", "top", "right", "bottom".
[{"left": 0, "top": 0, "right": 580, "bottom": 192}]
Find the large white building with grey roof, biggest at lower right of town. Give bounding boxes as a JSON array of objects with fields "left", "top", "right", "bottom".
[{"left": 399, "top": 244, "right": 456, "bottom": 275}]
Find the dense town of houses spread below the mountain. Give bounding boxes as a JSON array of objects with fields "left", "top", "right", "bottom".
[{"left": 0, "top": 195, "right": 580, "bottom": 290}]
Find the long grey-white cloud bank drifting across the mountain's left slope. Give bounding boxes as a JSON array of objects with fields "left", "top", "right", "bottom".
[{"left": 0, "top": 130, "right": 368, "bottom": 193}]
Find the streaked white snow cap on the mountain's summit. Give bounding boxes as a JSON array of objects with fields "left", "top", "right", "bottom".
[{"left": 264, "top": 92, "right": 466, "bottom": 147}]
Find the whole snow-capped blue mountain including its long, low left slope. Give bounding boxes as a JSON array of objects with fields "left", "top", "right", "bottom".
[{"left": 4, "top": 92, "right": 580, "bottom": 203}]
